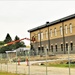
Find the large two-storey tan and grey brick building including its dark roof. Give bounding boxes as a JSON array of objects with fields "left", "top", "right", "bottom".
[{"left": 28, "top": 14, "right": 75, "bottom": 54}]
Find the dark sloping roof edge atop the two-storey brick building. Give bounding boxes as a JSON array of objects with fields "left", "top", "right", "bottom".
[{"left": 28, "top": 14, "right": 75, "bottom": 32}]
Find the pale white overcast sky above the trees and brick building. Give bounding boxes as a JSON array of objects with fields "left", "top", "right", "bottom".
[{"left": 0, "top": 0, "right": 75, "bottom": 45}]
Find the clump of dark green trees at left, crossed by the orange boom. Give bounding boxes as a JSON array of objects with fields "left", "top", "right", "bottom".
[{"left": 0, "top": 33, "right": 26, "bottom": 53}]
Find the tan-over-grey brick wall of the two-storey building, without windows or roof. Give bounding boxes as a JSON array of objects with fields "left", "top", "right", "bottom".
[{"left": 30, "top": 18, "right": 75, "bottom": 54}]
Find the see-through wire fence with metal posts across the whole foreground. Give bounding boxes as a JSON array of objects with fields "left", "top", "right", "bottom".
[{"left": 0, "top": 47, "right": 75, "bottom": 75}]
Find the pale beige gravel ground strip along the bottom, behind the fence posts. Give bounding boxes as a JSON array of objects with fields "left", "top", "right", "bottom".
[{"left": 0, "top": 63, "right": 75, "bottom": 75}]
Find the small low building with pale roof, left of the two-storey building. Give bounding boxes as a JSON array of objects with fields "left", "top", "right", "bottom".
[{"left": 6, "top": 47, "right": 30, "bottom": 58}]
